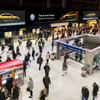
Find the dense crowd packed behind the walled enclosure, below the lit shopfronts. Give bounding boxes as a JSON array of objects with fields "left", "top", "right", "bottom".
[{"left": 53, "top": 24, "right": 100, "bottom": 39}]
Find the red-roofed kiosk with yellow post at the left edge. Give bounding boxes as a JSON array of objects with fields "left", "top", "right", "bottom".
[{"left": 0, "top": 60, "right": 23, "bottom": 87}]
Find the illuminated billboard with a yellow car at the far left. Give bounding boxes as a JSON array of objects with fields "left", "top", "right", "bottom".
[{"left": 0, "top": 10, "right": 25, "bottom": 26}]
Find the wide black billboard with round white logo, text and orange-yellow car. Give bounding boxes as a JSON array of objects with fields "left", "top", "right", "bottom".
[{"left": 26, "top": 9, "right": 79, "bottom": 25}]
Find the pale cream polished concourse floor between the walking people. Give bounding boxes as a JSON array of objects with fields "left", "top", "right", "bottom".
[{"left": 0, "top": 40, "right": 100, "bottom": 100}]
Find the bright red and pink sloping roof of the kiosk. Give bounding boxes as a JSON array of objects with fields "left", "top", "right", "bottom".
[{"left": 0, "top": 60, "right": 23, "bottom": 73}]
